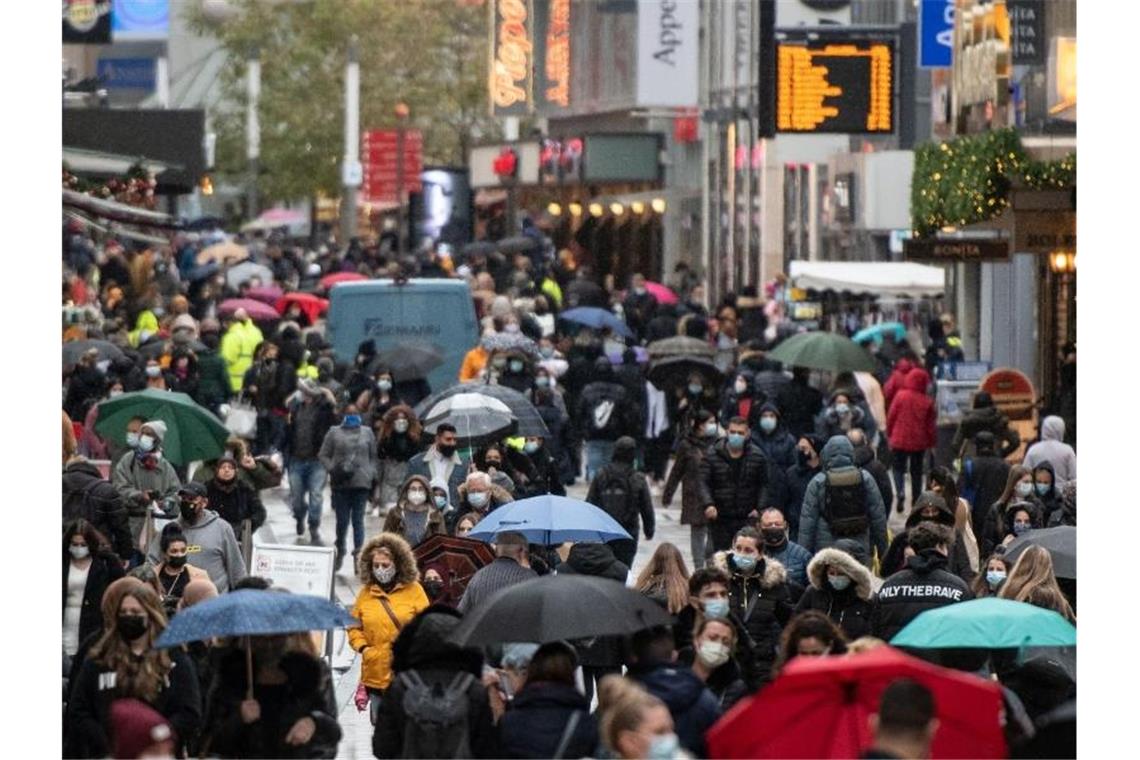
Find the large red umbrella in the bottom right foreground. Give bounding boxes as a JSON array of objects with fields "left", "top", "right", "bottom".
[{"left": 706, "top": 646, "right": 1007, "bottom": 759}]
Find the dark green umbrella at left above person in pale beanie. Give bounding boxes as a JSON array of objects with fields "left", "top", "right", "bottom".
[{"left": 95, "top": 389, "right": 229, "bottom": 465}]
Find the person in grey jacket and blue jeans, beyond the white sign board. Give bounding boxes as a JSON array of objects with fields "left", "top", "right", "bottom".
[{"left": 317, "top": 403, "right": 376, "bottom": 571}]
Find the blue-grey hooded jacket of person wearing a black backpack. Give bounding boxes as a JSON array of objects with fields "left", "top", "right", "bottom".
[{"left": 797, "top": 435, "right": 887, "bottom": 557}]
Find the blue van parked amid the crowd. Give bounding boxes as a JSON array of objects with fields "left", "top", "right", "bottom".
[{"left": 326, "top": 278, "right": 479, "bottom": 392}]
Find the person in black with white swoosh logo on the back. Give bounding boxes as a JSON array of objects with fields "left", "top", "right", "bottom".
[{"left": 575, "top": 357, "right": 637, "bottom": 481}]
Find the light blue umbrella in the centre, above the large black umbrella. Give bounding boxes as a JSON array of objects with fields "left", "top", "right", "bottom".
[{"left": 467, "top": 493, "right": 630, "bottom": 546}]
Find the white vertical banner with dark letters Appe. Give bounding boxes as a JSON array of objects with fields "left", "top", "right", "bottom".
[{"left": 637, "top": 0, "right": 697, "bottom": 106}]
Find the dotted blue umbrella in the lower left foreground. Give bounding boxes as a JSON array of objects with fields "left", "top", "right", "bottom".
[{"left": 155, "top": 589, "right": 360, "bottom": 648}]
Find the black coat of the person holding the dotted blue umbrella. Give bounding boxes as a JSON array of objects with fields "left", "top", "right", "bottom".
[{"left": 203, "top": 648, "right": 341, "bottom": 758}]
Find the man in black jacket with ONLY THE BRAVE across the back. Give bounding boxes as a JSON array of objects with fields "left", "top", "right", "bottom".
[{"left": 871, "top": 521, "right": 974, "bottom": 641}]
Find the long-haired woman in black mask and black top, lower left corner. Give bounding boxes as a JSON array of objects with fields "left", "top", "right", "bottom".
[{"left": 66, "top": 585, "right": 202, "bottom": 758}]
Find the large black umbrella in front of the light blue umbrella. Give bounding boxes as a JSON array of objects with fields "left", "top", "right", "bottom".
[{"left": 451, "top": 575, "right": 673, "bottom": 646}]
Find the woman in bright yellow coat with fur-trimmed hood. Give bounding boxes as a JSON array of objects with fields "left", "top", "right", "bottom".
[{"left": 349, "top": 533, "right": 431, "bottom": 725}]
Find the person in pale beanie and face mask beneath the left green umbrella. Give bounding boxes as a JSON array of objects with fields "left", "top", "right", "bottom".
[{"left": 111, "top": 419, "right": 181, "bottom": 564}]
